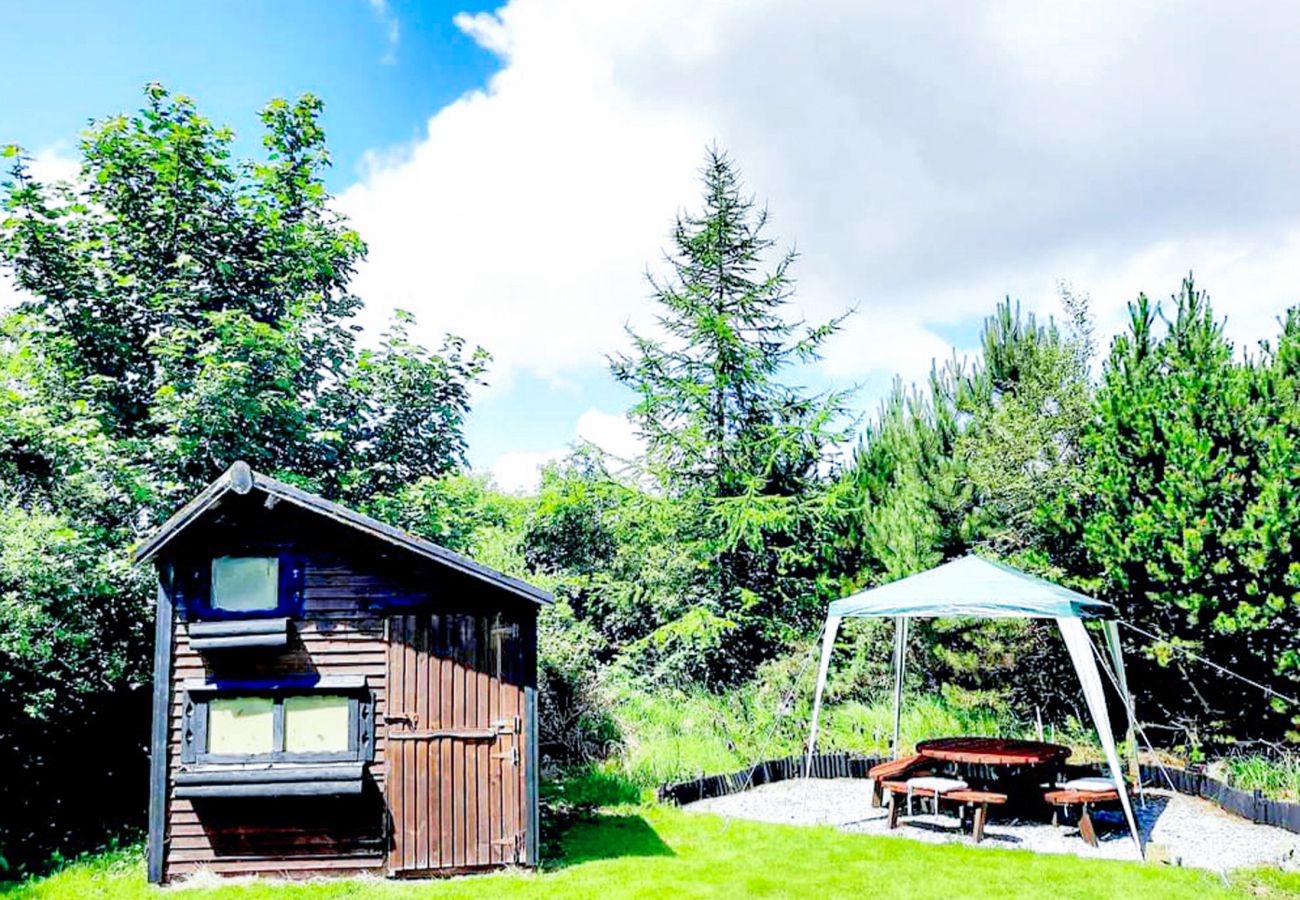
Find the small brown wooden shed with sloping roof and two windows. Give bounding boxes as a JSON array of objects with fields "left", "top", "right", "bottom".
[{"left": 137, "top": 463, "right": 551, "bottom": 882}]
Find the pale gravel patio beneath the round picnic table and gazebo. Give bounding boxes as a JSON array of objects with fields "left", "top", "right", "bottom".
[{"left": 684, "top": 778, "right": 1300, "bottom": 871}]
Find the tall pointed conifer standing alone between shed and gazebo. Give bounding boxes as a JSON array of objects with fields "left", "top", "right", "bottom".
[{"left": 611, "top": 150, "right": 845, "bottom": 674}]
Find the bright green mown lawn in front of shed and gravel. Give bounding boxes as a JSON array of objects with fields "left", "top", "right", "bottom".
[{"left": 10, "top": 806, "right": 1300, "bottom": 900}]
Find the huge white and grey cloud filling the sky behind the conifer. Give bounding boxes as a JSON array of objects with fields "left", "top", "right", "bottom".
[{"left": 341, "top": 0, "right": 1300, "bottom": 397}]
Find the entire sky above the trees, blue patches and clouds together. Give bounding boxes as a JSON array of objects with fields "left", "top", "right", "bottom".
[{"left": 0, "top": 0, "right": 1300, "bottom": 488}]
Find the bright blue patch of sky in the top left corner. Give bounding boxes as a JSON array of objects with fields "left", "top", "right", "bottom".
[{"left": 0, "top": 0, "right": 498, "bottom": 191}]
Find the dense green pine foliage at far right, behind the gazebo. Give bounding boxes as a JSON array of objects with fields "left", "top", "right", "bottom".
[{"left": 1057, "top": 278, "right": 1300, "bottom": 740}]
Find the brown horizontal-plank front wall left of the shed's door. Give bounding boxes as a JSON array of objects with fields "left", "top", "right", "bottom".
[{"left": 164, "top": 553, "right": 413, "bottom": 879}]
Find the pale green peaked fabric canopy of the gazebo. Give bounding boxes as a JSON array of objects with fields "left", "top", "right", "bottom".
[{"left": 829, "top": 555, "right": 1115, "bottom": 619}]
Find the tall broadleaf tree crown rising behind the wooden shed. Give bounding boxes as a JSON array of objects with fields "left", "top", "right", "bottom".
[{"left": 0, "top": 85, "right": 488, "bottom": 502}]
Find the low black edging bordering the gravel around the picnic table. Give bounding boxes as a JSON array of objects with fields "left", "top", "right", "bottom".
[{"left": 655, "top": 753, "right": 1300, "bottom": 834}]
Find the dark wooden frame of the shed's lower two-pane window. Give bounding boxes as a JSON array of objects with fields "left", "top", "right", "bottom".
[{"left": 181, "top": 679, "right": 374, "bottom": 765}]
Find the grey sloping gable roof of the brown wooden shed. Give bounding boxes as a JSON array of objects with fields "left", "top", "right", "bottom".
[{"left": 135, "top": 462, "right": 554, "bottom": 603}]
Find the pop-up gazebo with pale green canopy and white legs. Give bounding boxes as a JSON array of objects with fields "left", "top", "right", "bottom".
[{"left": 805, "top": 555, "right": 1143, "bottom": 854}]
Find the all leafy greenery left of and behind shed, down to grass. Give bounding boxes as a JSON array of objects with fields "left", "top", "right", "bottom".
[{"left": 0, "top": 85, "right": 495, "bottom": 867}]
